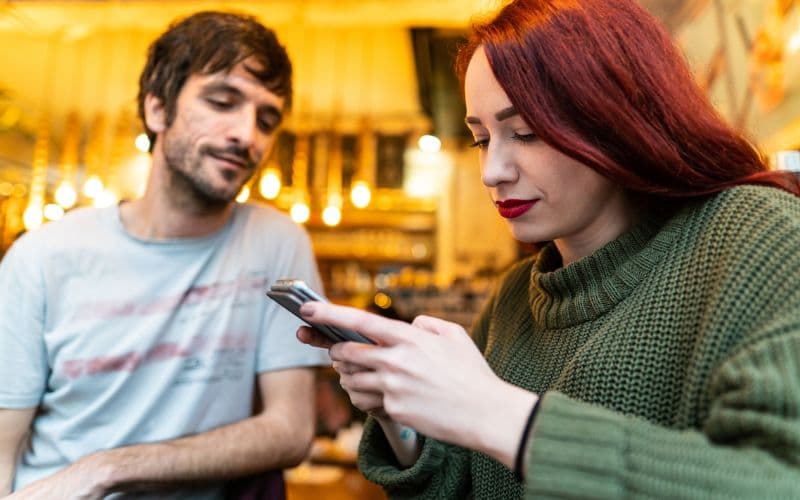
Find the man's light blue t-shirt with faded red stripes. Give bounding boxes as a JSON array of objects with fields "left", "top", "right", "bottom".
[{"left": 0, "top": 205, "right": 329, "bottom": 498}]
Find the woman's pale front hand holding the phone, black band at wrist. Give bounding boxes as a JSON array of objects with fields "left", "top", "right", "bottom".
[{"left": 301, "top": 302, "right": 536, "bottom": 464}]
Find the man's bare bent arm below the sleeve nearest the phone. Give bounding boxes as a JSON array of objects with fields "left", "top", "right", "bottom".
[{"left": 11, "top": 368, "right": 314, "bottom": 498}]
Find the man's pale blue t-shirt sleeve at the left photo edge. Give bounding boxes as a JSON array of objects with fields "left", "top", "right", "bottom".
[{"left": 0, "top": 237, "right": 48, "bottom": 409}]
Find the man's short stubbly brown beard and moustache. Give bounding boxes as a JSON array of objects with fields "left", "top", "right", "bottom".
[{"left": 164, "top": 133, "right": 254, "bottom": 213}]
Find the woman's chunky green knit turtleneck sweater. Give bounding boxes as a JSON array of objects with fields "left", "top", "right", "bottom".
[{"left": 359, "top": 186, "right": 800, "bottom": 499}]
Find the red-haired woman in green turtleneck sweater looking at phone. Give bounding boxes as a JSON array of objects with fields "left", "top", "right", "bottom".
[{"left": 298, "top": 0, "right": 800, "bottom": 499}]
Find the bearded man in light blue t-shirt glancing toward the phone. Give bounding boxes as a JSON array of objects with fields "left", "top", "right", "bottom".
[{"left": 0, "top": 12, "right": 328, "bottom": 499}]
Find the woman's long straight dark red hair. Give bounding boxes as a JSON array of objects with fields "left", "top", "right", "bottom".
[{"left": 457, "top": 0, "right": 800, "bottom": 198}]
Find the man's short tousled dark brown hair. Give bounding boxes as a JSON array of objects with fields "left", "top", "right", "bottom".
[{"left": 138, "top": 12, "right": 292, "bottom": 145}]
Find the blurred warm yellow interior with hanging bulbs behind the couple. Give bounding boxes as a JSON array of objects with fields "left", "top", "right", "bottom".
[{"left": 0, "top": 0, "right": 800, "bottom": 498}]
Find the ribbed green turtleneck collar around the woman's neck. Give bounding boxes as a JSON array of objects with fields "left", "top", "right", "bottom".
[{"left": 528, "top": 212, "right": 685, "bottom": 329}]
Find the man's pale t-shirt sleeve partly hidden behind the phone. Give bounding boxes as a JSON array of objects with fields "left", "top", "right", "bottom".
[{"left": 256, "top": 227, "right": 330, "bottom": 373}]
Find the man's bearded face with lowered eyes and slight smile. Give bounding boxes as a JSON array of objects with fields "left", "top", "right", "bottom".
[{"left": 161, "top": 59, "right": 284, "bottom": 207}]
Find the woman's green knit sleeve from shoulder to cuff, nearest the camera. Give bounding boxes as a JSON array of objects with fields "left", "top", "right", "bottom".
[{"left": 525, "top": 187, "right": 800, "bottom": 499}]
